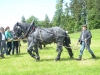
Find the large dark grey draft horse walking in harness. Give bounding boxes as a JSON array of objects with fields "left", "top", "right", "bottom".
[{"left": 13, "top": 22, "right": 73, "bottom": 61}]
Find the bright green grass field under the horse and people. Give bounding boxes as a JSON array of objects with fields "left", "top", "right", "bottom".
[{"left": 0, "top": 29, "right": 100, "bottom": 75}]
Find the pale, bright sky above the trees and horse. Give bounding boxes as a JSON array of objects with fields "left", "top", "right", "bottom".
[{"left": 0, "top": 0, "right": 70, "bottom": 30}]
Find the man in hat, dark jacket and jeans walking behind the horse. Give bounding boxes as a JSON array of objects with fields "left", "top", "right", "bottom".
[{"left": 76, "top": 25, "right": 96, "bottom": 60}]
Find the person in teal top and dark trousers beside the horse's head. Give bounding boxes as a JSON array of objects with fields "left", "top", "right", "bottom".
[{"left": 5, "top": 26, "right": 13, "bottom": 55}]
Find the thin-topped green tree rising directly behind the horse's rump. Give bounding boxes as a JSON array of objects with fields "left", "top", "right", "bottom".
[{"left": 63, "top": 3, "right": 75, "bottom": 33}]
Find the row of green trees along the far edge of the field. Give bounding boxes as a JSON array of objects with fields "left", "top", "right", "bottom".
[{"left": 21, "top": 0, "right": 100, "bottom": 33}]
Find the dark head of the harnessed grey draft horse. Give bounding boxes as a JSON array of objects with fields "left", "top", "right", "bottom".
[{"left": 13, "top": 22, "right": 23, "bottom": 37}]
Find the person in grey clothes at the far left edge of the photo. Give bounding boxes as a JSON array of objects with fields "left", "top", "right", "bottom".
[{"left": 0, "top": 27, "right": 7, "bottom": 58}]
